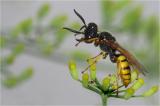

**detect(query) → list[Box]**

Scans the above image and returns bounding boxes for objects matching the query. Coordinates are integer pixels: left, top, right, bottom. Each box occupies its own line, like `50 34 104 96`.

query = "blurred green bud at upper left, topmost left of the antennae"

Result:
37 3 51 19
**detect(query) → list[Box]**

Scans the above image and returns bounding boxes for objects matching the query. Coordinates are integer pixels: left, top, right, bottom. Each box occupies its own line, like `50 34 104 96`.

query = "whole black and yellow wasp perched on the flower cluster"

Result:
64 9 147 87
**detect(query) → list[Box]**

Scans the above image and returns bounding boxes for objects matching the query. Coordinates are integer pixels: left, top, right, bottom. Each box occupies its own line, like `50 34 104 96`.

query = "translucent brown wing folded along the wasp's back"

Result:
105 40 147 75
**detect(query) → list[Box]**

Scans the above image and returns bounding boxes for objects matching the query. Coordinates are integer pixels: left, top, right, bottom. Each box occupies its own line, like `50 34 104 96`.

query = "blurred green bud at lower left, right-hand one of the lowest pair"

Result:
17 67 33 81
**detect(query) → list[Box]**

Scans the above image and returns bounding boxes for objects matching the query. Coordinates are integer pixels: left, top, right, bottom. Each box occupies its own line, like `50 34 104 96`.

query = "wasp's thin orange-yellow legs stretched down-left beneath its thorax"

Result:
82 52 107 73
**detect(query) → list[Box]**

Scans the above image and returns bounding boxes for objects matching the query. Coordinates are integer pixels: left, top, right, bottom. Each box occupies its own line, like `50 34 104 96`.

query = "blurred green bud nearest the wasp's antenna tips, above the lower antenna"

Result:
50 15 68 29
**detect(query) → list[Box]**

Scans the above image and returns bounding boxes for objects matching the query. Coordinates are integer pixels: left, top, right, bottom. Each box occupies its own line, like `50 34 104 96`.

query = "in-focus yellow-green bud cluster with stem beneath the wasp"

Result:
69 61 159 106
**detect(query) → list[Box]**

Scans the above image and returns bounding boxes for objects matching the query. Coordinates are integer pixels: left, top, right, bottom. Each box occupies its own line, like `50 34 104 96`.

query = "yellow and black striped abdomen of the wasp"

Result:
117 55 131 87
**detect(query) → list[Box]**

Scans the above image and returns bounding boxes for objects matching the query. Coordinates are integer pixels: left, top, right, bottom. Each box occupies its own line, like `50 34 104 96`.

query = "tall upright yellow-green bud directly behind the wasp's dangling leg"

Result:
88 59 96 80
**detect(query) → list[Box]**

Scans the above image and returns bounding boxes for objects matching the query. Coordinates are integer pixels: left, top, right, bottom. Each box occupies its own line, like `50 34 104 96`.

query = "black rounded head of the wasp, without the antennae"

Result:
85 23 98 39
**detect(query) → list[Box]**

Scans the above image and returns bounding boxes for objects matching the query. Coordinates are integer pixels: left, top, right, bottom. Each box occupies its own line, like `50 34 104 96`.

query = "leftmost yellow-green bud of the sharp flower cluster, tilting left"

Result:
69 61 78 80
